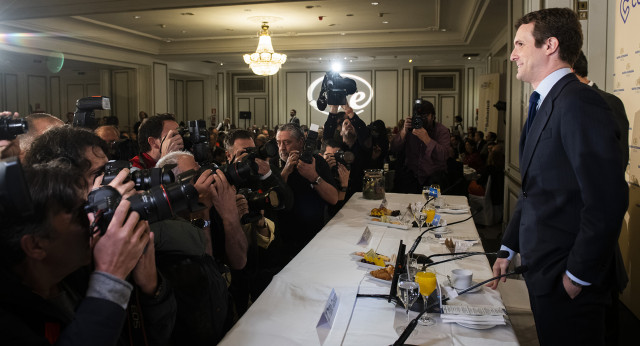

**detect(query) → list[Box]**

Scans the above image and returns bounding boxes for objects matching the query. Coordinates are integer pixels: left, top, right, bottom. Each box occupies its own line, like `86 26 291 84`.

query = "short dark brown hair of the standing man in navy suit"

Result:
515 8 583 66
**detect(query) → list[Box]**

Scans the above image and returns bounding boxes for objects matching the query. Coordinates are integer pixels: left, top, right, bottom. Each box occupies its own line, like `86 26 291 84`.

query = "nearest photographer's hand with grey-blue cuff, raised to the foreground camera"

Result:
89 200 150 280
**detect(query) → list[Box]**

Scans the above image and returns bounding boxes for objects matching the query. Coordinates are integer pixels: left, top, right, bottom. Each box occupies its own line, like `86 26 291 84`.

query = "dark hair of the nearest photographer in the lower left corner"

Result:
0 159 89 267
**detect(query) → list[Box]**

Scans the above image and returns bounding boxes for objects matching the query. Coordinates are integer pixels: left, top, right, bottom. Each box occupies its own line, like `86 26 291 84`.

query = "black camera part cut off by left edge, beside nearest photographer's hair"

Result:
0 157 33 216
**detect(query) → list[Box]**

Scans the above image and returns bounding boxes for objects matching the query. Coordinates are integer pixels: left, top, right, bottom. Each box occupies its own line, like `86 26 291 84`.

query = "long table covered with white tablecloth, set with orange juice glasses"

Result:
221 193 518 345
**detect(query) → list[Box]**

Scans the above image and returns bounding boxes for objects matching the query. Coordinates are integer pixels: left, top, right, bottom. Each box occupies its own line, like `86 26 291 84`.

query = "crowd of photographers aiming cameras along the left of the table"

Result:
0 74 504 345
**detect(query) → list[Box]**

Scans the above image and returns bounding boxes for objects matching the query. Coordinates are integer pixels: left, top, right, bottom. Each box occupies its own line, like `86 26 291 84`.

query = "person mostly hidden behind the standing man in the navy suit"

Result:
573 51 629 170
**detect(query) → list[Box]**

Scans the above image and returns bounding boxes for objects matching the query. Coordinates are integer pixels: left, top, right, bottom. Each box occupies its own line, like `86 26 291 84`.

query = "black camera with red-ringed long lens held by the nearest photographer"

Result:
84 176 201 235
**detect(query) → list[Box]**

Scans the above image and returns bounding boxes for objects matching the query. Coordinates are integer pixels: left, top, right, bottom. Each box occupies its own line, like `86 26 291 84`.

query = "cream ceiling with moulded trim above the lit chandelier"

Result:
0 0 507 68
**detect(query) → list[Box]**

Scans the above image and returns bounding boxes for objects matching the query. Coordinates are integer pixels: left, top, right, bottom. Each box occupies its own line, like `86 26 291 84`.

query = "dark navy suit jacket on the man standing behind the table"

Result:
503 74 628 295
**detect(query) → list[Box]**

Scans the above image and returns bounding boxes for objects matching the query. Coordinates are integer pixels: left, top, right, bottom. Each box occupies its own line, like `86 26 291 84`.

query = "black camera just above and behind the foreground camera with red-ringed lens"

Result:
102 160 176 190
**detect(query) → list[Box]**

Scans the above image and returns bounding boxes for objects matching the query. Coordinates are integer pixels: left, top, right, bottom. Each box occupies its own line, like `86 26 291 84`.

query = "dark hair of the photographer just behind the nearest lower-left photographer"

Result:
24 125 109 173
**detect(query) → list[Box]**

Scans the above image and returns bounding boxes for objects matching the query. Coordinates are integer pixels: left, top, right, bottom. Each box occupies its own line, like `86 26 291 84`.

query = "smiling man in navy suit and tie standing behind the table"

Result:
491 8 628 345
